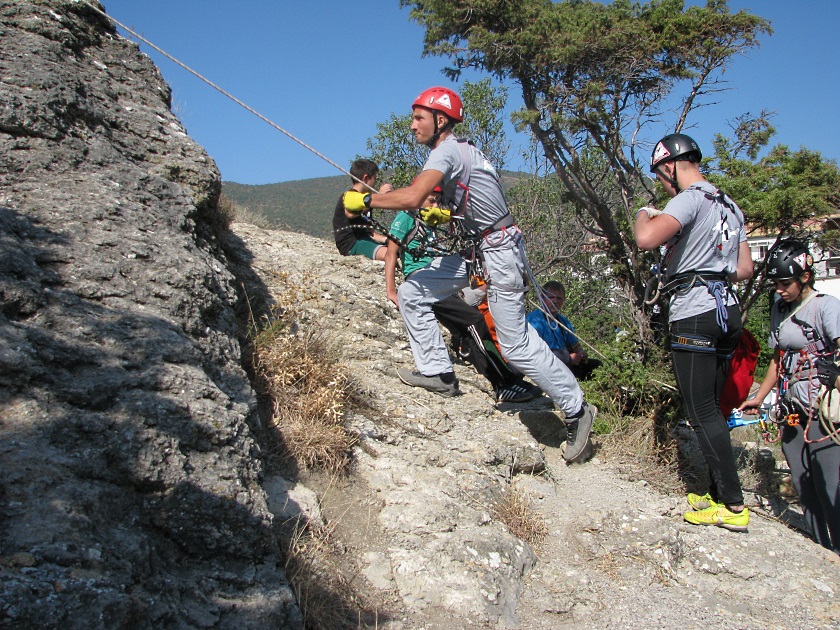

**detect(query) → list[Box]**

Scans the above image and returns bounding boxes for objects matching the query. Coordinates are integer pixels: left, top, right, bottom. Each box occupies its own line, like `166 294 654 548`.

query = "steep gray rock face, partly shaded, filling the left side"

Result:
0 0 300 628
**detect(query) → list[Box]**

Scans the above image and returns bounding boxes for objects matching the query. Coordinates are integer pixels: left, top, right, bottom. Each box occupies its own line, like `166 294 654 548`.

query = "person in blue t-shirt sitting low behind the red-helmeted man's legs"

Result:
525 280 601 381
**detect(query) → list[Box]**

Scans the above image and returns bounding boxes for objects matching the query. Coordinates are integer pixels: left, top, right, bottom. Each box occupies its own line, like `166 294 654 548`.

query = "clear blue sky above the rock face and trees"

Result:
102 0 840 184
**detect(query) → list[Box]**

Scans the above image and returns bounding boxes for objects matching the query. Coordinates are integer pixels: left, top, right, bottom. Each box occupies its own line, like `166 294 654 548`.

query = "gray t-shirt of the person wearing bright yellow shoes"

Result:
663 181 747 322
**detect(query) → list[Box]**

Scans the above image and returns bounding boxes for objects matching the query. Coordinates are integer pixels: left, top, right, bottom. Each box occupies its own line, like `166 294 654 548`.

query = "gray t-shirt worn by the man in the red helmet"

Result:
423 135 508 231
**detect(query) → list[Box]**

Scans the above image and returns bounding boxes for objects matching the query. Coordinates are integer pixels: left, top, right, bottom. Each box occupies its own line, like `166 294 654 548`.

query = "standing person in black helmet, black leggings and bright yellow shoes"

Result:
635 133 753 531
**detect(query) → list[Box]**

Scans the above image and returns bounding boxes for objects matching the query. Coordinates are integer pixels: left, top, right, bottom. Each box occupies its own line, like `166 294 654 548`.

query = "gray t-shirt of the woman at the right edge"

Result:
768 294 840 409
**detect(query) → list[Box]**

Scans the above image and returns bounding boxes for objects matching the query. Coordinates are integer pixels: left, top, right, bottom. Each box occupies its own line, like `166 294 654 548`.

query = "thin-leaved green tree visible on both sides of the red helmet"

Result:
367 78 510 187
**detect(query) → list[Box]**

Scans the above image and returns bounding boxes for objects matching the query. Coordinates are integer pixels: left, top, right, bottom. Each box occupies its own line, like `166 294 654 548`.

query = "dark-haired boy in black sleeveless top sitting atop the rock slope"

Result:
333 158 392 260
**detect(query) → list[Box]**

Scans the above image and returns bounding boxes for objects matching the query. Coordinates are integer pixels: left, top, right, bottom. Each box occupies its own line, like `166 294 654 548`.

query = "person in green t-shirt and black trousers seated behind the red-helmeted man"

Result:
385 187 535 402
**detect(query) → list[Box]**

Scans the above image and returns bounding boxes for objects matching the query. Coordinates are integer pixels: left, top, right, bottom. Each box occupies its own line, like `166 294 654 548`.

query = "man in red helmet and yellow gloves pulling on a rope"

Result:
344 87 597 463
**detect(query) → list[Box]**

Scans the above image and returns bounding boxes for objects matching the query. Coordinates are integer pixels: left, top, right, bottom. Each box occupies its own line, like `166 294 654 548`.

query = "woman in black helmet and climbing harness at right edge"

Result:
741 240 840 553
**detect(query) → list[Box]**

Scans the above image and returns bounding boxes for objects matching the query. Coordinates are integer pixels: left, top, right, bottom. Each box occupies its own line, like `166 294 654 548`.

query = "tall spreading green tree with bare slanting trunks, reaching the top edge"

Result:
401 0 770 301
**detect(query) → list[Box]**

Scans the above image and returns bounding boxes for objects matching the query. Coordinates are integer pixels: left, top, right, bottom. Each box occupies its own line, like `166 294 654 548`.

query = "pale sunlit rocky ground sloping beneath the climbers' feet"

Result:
234 224 840 629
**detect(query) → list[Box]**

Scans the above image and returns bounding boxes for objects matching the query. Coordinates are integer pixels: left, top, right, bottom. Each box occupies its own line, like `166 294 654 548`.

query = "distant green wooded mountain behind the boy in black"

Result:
222 171 523 240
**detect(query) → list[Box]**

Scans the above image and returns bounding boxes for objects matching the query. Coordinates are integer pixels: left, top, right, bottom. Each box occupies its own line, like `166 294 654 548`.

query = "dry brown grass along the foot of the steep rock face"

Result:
250 274 376 630
